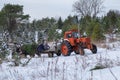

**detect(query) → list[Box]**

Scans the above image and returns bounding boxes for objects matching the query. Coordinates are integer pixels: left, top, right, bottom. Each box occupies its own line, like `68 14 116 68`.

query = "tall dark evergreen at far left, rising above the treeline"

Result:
0 4 29 39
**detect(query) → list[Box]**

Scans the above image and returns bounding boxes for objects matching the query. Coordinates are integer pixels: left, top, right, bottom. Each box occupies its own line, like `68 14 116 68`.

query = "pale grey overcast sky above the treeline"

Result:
0 0 120 20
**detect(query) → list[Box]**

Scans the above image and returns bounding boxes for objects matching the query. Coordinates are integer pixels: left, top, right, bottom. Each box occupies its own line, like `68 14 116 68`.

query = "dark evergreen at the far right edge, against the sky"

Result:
102 10 120 34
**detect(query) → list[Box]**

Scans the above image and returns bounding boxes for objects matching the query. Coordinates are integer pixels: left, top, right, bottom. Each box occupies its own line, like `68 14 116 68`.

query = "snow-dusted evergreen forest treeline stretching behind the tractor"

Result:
0 2 120 42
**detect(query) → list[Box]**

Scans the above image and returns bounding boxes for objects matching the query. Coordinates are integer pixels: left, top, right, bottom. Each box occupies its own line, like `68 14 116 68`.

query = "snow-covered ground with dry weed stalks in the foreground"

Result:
0 42 120 80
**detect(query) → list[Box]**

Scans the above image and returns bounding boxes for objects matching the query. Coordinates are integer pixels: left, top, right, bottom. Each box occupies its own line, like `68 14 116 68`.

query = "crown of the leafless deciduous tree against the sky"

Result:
73 0 104 17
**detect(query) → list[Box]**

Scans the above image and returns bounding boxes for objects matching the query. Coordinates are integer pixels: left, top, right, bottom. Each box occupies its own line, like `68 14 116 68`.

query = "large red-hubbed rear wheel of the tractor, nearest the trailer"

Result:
61 41 72 56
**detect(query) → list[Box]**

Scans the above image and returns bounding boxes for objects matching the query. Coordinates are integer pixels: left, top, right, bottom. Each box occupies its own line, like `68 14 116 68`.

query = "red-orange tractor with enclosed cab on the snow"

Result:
59 30 97 56
